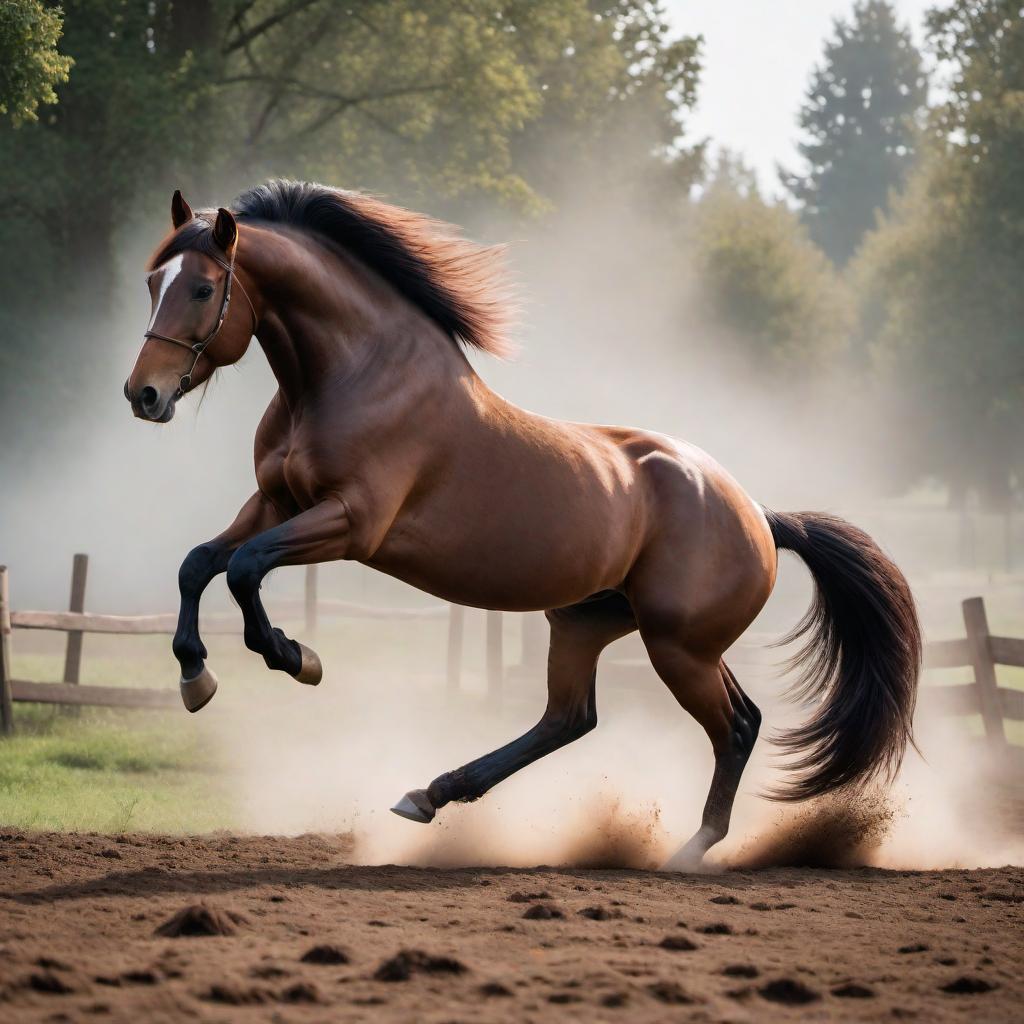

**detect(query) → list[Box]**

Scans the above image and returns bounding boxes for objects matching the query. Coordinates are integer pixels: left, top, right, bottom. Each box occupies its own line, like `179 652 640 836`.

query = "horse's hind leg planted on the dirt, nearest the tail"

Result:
641 625 761 871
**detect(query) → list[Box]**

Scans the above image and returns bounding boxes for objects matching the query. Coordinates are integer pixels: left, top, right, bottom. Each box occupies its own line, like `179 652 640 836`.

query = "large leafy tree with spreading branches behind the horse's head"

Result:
0 0 696 308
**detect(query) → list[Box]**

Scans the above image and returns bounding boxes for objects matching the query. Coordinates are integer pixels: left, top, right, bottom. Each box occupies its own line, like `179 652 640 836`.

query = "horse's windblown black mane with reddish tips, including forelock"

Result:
151 179 511 356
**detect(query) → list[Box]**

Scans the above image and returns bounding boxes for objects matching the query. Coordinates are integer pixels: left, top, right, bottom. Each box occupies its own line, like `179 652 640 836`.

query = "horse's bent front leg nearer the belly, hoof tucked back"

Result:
227 497 349 686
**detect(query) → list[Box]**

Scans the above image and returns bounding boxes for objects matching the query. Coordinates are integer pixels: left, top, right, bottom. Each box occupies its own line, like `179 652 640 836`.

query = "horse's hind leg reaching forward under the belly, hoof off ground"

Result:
391 593 636 823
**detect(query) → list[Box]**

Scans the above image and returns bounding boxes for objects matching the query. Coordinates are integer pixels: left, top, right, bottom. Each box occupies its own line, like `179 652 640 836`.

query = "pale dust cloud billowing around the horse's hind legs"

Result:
195 614 1024 870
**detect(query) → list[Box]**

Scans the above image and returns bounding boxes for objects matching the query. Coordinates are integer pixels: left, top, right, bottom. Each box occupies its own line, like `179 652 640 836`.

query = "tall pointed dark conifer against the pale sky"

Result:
781 0 927 266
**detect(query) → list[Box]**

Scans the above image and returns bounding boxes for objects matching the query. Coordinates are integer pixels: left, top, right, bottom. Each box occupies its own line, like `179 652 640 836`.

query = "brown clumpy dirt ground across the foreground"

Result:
0 831 1024 1022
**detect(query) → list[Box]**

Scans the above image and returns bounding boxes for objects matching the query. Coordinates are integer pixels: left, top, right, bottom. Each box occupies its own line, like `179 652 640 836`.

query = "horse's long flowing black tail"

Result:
765 509 921 800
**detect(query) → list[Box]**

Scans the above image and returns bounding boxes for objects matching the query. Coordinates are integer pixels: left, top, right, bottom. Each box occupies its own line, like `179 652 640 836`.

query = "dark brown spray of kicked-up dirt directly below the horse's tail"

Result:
727 791 895 868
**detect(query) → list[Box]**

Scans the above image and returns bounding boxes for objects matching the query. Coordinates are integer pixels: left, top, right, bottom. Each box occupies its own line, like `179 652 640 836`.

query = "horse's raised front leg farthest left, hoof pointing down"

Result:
171 492 282 712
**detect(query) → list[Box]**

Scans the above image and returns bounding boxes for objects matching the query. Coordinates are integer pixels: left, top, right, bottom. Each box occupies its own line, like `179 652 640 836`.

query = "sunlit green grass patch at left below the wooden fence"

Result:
0 705 231 833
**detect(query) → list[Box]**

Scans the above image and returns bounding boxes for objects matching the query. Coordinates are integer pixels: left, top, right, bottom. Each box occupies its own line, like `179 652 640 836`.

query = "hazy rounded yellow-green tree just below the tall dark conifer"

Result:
691 154 852 373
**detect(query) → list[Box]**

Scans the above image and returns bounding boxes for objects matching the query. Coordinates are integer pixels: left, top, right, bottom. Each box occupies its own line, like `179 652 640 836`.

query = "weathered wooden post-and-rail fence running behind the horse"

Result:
0 554 1024 749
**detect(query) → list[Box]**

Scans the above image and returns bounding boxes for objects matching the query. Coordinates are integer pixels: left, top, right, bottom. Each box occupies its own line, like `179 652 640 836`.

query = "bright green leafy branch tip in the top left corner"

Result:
0 0 72 126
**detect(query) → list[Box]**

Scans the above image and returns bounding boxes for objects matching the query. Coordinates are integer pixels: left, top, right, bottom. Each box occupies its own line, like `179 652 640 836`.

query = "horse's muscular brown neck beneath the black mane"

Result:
239 227 475 409
